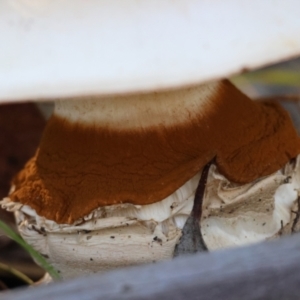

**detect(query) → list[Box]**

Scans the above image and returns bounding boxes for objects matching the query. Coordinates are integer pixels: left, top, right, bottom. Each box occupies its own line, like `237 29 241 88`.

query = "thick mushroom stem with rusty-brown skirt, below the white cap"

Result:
1 81 300 278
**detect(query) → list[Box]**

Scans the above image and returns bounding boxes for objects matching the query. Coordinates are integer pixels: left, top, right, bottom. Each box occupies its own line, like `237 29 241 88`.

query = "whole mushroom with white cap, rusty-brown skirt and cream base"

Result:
0 0 300 278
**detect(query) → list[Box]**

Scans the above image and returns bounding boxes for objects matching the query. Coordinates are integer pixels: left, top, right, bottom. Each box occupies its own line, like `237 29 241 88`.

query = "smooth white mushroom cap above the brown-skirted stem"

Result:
0 0 300 101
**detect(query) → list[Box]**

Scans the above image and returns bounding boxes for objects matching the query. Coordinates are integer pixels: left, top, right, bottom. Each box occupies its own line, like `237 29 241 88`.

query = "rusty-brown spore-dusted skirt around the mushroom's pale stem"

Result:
10 81 300 224
